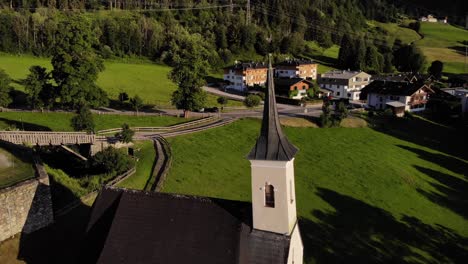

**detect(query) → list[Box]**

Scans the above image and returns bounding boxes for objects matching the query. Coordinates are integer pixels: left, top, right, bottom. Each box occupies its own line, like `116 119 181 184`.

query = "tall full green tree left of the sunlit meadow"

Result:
52 14 107 108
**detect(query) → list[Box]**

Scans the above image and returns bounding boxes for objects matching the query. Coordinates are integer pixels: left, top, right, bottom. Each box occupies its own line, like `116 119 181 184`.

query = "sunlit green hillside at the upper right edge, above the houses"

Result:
416 22 468 73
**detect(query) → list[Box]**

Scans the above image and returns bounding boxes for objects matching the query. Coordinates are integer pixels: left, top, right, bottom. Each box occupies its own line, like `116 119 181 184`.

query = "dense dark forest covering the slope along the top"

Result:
0 0 463 71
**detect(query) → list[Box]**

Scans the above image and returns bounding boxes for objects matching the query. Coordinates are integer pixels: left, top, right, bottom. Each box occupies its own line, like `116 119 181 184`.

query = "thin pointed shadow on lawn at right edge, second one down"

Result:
397 145 468 175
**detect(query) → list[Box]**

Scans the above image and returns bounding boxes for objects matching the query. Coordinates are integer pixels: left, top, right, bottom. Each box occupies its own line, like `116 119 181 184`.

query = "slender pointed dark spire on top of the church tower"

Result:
247 57 297 161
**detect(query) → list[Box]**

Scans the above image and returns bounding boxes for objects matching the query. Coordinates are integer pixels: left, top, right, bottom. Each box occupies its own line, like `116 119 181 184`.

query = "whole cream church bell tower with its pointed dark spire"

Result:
247 56 297 235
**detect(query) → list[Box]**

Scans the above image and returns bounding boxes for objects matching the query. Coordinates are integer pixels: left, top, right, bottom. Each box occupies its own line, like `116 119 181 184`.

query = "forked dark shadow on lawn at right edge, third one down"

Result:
414 166 468 219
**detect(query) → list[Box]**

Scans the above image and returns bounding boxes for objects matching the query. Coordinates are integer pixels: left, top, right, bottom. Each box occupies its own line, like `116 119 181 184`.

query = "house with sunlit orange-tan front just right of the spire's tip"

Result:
275 59 317 80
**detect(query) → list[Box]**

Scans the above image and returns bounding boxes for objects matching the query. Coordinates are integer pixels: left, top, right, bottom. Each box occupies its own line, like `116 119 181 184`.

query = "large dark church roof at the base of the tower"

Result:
80 187 290 264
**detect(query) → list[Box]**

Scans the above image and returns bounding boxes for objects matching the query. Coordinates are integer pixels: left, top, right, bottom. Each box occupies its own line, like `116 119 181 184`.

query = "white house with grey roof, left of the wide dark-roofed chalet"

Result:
317 70 371 100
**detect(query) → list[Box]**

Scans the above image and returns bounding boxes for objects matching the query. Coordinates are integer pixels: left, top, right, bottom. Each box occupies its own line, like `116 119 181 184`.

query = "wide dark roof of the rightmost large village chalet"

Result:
361 80 432 96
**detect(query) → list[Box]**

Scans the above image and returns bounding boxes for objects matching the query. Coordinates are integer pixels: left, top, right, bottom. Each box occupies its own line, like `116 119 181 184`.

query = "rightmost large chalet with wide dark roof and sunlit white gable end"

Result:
366 81 434 115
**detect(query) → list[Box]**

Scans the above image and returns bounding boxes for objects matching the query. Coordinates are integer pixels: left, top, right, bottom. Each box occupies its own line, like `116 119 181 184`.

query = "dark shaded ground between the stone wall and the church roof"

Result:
17 180 90 264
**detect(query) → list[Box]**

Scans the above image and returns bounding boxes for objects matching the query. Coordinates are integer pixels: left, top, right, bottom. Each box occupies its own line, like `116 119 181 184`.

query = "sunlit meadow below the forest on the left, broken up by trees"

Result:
0 53 242 107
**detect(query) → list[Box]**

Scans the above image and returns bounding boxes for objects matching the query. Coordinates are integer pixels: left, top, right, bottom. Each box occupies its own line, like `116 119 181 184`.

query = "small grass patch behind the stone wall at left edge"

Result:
0 148 35 188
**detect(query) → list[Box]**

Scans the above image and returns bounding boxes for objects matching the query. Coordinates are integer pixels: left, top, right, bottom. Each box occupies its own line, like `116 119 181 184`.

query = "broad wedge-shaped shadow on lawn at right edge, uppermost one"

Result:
368 117 468 160
